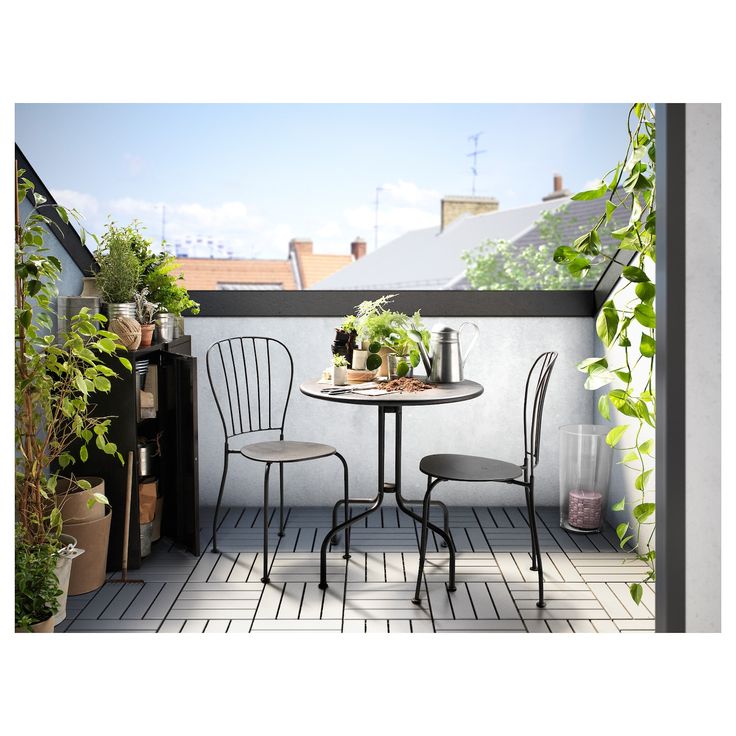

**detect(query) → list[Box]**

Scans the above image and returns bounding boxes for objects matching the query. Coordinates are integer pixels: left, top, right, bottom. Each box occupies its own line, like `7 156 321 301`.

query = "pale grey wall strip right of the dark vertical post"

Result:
685 105 721 631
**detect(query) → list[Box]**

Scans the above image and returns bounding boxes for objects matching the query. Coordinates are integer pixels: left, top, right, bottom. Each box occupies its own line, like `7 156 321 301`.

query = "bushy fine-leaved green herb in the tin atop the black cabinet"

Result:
94 222 141 304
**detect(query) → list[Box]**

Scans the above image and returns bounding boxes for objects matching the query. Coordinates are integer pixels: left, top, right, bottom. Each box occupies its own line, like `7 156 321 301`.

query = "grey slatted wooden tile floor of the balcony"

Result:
56 506 654 634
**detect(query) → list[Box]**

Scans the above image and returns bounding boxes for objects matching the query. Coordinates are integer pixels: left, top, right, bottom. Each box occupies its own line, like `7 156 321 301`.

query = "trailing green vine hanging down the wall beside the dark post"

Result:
554 102 657 604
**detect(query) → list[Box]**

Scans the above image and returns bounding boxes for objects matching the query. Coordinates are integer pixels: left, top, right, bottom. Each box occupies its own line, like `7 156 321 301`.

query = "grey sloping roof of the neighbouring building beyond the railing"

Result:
312 198 620 290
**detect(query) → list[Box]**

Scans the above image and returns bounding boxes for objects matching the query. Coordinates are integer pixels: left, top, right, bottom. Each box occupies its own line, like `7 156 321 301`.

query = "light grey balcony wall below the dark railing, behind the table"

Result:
186 316 595 506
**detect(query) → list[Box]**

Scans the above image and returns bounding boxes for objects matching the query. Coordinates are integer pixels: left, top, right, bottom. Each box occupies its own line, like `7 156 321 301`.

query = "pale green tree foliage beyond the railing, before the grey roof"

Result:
462 204 610 291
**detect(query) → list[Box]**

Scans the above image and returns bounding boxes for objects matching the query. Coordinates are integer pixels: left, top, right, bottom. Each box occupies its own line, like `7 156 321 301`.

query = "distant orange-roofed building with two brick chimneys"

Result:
177 238 366 291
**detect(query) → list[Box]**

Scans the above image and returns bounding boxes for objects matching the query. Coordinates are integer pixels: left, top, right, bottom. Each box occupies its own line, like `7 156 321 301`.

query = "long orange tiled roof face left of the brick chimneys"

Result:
172 258 296 291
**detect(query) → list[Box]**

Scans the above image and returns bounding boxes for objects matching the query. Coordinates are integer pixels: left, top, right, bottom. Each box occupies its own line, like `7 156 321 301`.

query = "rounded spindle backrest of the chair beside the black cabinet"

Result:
206 337 294 441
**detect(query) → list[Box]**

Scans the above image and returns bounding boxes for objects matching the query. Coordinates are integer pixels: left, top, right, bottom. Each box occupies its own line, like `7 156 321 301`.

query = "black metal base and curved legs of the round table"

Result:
319 406 456 592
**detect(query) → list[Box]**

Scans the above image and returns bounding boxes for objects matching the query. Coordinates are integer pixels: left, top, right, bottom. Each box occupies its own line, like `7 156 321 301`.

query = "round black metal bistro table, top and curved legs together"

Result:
299 381 483 591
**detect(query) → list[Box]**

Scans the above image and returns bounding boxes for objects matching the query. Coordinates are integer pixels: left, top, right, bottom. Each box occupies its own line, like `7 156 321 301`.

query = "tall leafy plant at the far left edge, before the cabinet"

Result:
15 171 131 630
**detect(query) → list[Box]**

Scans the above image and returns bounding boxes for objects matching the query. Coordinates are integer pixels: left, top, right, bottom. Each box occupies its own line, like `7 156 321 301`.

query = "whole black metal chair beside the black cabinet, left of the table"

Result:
206 337 350 583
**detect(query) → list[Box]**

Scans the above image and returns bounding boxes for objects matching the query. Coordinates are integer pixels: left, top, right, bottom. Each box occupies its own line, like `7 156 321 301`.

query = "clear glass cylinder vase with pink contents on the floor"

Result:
560 424 613 534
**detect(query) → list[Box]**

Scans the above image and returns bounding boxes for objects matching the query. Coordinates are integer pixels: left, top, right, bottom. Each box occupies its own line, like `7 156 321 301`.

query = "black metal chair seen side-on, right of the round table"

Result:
412 353 557 608
